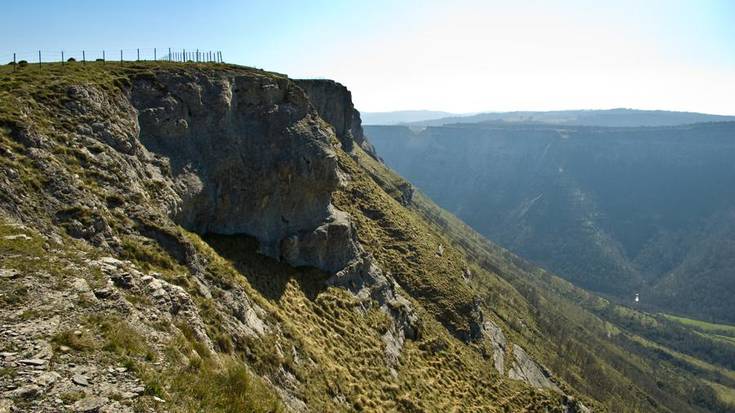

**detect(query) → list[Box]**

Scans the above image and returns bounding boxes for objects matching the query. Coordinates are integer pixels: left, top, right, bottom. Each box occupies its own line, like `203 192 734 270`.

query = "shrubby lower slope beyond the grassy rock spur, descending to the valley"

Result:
350 146 735 411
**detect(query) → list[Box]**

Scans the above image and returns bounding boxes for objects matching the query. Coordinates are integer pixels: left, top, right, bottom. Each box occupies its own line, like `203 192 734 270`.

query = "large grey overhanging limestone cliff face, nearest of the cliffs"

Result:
131 72 359 273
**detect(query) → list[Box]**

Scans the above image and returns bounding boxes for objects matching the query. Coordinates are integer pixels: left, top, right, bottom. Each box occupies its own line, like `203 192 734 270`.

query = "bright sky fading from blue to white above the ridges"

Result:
0 0 735 115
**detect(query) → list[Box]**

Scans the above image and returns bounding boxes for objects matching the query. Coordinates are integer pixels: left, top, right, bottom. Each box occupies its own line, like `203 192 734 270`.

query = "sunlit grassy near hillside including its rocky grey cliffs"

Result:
0 62 735 412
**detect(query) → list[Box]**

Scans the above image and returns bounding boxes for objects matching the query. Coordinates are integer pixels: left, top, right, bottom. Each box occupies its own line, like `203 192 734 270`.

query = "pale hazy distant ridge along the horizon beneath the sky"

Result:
363 108 735 127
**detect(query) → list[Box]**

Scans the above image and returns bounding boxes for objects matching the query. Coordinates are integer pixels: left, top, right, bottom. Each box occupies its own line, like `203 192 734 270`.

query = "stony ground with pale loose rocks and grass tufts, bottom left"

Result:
0 224 196 413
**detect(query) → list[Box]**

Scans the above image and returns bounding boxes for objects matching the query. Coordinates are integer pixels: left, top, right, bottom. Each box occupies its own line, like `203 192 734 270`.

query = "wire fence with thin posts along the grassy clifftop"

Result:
0 47 224 66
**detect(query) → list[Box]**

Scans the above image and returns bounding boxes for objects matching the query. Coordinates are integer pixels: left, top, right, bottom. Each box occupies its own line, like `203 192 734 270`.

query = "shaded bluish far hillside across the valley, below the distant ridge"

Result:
367 122 735 323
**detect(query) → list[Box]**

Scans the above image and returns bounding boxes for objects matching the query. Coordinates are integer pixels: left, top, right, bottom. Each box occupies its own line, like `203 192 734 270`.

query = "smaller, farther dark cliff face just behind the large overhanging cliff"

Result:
296 79 377 158
